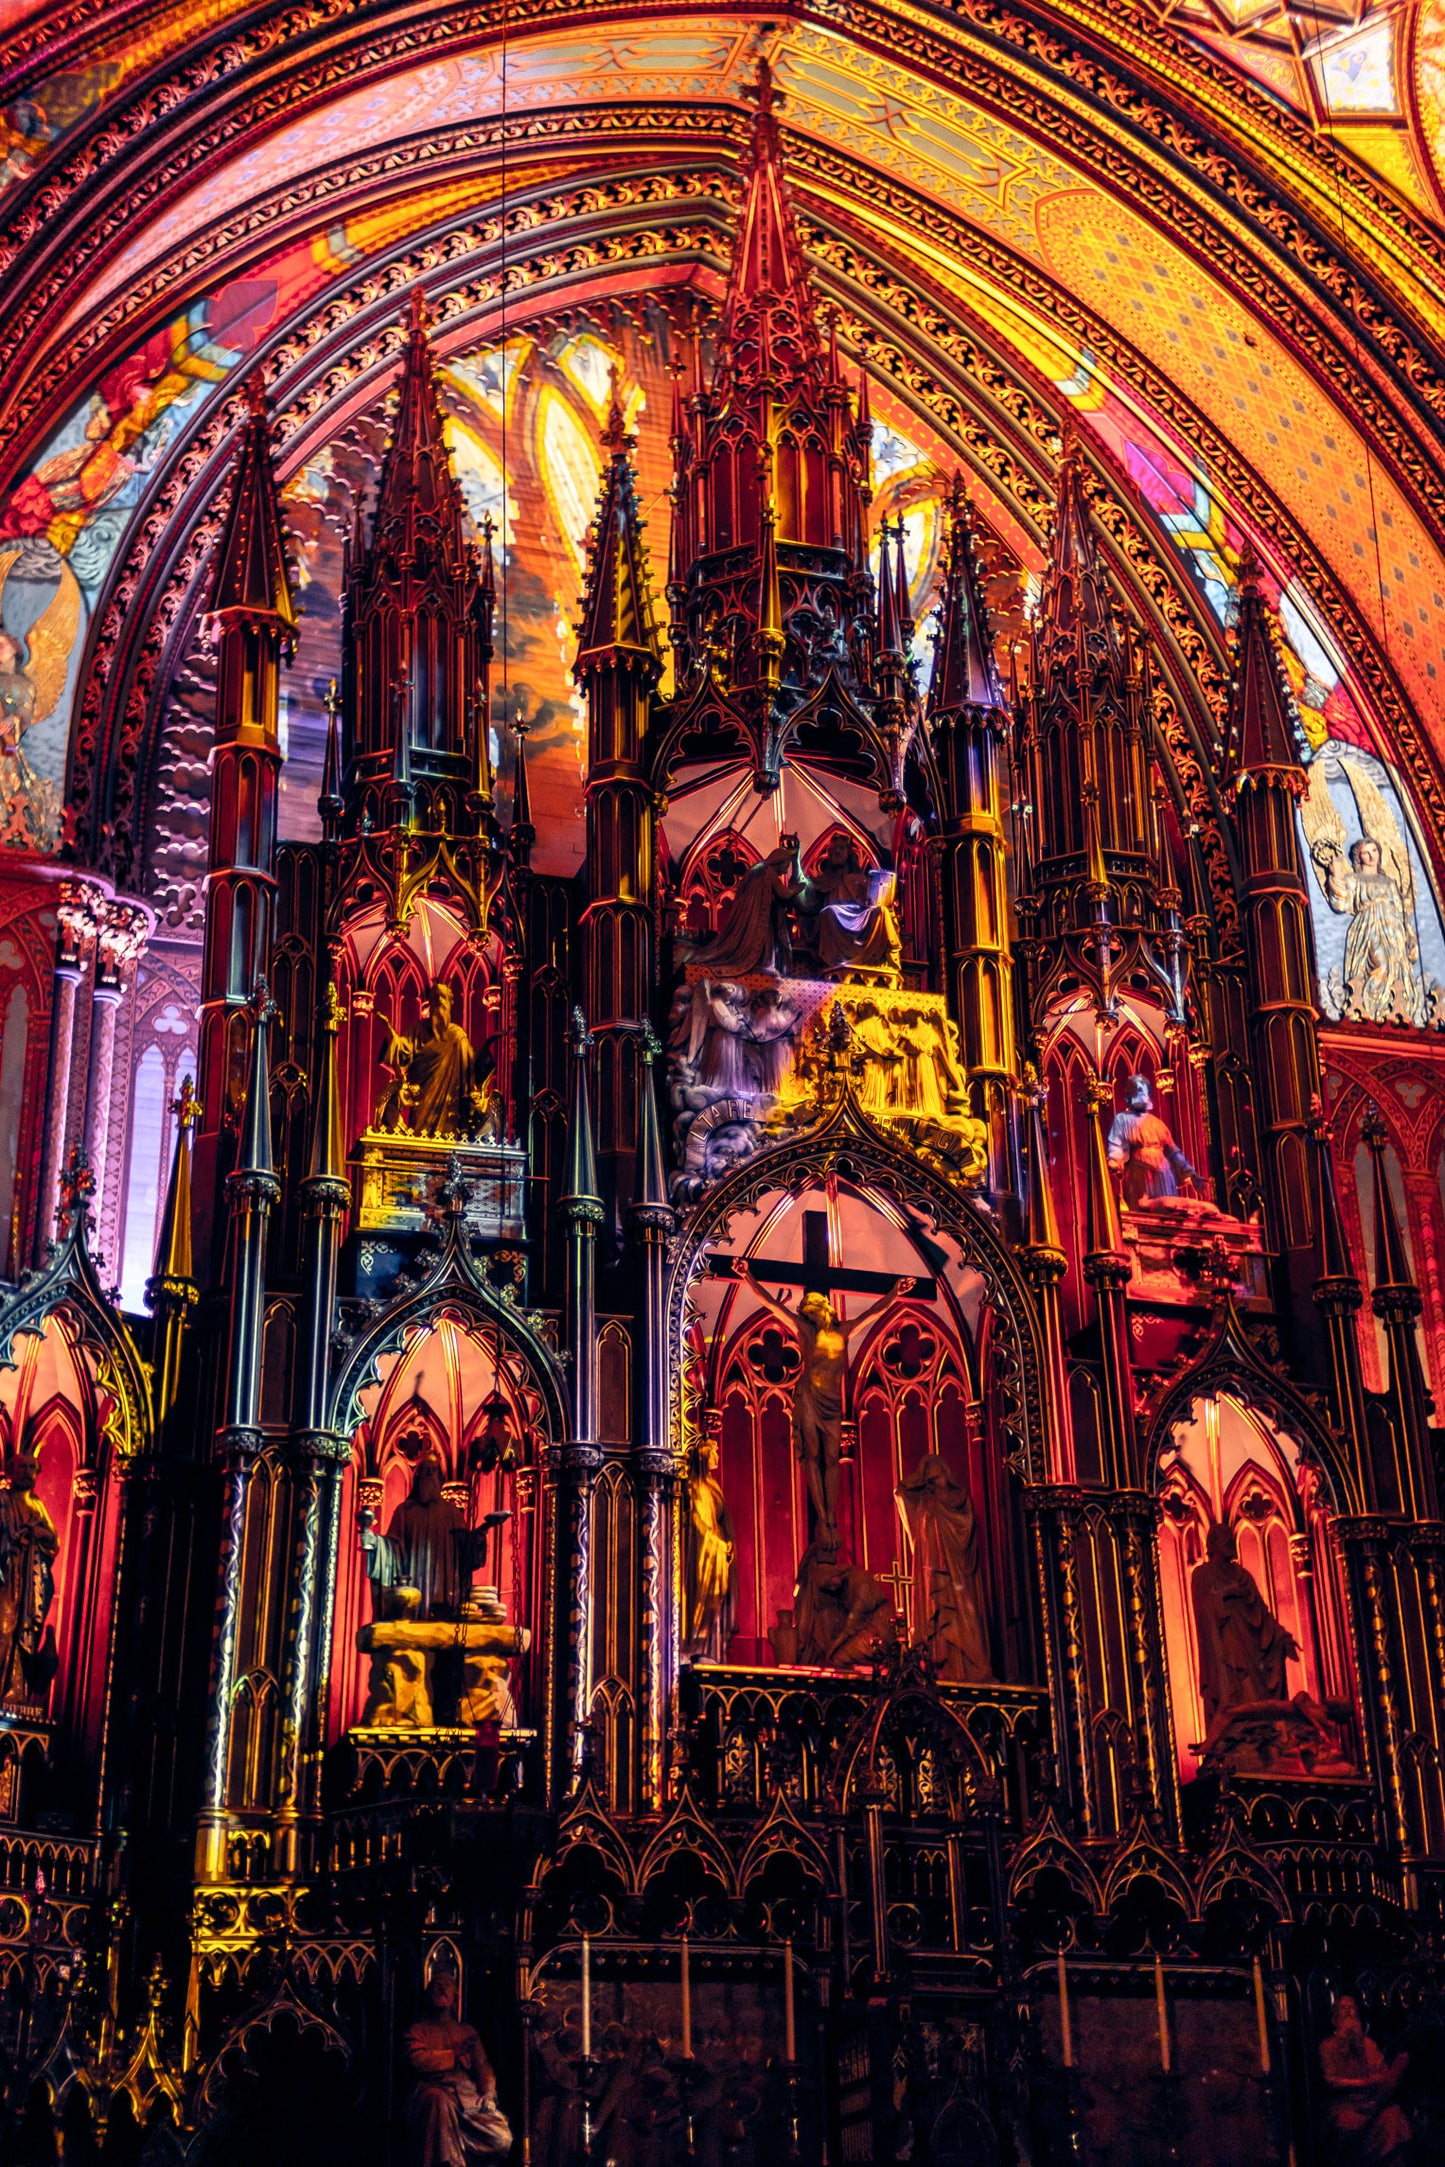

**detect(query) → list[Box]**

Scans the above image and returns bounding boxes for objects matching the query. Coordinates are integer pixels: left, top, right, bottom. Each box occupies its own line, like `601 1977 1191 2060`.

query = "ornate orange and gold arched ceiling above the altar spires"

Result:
0 0 1445 905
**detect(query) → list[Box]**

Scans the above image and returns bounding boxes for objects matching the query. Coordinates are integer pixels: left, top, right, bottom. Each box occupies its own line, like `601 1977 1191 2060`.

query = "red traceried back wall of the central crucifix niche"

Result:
687 1177 1027 1677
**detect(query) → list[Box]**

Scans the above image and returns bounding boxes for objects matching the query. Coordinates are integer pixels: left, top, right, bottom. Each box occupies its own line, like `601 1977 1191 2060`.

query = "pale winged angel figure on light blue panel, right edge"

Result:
1300 745 1426 1023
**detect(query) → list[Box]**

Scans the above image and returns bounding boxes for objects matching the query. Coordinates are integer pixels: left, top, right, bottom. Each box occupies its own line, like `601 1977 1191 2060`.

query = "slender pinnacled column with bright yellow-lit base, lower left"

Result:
195 979 282 1881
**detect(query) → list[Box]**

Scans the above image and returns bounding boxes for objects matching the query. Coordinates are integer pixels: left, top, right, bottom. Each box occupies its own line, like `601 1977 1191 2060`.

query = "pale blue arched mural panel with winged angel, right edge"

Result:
1300 739 1445 1025
